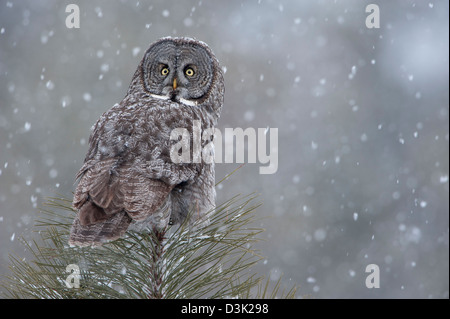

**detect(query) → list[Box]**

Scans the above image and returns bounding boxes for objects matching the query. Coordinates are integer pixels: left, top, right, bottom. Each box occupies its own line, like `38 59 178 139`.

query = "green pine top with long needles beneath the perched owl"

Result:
0 195 295 299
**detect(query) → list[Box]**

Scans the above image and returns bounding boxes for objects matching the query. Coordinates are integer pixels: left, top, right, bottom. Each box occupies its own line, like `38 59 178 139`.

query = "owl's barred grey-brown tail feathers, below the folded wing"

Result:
69 211 131 247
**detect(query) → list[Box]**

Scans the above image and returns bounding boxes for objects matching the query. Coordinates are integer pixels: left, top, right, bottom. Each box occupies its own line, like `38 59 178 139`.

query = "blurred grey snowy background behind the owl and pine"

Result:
0 0 449 298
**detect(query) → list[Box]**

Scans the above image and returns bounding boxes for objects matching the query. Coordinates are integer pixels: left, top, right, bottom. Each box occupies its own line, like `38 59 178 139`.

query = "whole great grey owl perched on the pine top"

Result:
69 37 224 246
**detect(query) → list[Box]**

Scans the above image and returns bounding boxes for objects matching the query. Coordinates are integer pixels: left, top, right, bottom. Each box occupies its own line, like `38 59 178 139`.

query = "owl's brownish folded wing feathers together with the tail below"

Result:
69 159 173 246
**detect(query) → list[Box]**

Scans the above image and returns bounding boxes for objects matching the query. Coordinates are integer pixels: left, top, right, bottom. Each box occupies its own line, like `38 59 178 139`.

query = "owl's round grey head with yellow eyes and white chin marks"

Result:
138 37 223 107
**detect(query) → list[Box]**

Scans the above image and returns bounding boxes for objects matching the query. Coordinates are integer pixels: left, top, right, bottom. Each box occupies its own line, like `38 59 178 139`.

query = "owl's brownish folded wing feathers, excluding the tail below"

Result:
73 159 173 225
